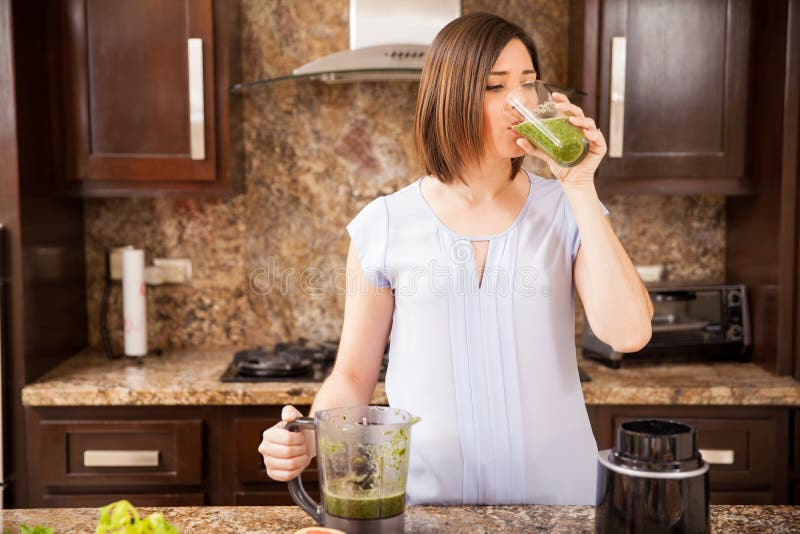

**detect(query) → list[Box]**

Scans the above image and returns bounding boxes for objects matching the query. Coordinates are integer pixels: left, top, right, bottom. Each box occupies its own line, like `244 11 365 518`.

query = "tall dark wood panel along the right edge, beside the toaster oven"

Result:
725 0 797 374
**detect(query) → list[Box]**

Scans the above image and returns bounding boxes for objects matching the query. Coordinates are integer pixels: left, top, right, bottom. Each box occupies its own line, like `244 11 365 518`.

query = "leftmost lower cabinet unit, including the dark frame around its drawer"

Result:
26 406 221 507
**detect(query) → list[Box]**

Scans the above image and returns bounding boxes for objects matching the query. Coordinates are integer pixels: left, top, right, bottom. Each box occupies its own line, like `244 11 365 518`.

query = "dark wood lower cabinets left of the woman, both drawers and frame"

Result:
26 406 319 507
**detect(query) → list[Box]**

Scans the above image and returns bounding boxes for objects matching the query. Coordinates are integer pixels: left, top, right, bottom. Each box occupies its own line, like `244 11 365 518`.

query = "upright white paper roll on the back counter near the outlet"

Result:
122 249 147 356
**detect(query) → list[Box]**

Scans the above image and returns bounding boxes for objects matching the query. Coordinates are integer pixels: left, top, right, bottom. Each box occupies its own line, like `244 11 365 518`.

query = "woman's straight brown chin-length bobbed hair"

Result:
414 13 541 183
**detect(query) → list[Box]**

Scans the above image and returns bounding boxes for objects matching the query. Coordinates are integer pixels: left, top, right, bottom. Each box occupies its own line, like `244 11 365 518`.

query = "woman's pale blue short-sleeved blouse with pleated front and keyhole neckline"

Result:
347 174 608 505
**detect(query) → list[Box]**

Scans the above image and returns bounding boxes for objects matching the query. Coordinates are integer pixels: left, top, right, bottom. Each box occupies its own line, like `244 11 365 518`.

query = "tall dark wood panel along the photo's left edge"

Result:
0 0 86 506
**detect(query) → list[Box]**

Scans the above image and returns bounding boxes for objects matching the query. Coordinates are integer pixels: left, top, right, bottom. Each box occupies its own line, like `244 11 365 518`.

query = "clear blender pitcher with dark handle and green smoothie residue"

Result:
286 406 419 534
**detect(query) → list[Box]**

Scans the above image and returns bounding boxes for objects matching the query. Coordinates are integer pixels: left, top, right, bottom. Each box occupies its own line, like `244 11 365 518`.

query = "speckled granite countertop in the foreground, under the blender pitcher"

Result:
0 506 800 534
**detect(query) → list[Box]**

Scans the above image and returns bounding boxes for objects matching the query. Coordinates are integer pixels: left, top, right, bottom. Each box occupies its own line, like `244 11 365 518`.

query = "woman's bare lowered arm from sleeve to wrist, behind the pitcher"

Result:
306 243 394 457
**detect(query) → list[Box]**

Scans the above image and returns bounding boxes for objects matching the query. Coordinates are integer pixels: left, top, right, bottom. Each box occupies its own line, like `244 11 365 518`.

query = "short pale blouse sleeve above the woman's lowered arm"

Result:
347 197 390 287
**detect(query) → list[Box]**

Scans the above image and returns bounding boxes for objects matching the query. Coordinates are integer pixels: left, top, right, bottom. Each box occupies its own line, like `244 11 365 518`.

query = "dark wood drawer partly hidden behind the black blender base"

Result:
613 414 778 490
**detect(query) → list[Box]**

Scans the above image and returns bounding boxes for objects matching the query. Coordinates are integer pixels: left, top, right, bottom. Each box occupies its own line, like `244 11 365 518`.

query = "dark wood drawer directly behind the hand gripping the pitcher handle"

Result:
233 417 318 484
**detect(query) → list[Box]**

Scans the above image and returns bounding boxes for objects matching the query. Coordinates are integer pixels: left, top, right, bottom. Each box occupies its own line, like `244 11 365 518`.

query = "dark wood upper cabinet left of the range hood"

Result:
50 0 238 196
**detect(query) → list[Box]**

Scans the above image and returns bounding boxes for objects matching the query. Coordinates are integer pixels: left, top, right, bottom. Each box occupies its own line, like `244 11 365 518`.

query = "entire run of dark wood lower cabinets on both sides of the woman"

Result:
27 406 800 507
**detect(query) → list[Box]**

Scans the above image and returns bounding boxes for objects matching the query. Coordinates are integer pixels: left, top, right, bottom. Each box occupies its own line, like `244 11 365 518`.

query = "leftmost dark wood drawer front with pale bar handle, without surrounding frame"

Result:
39 419 203 488
